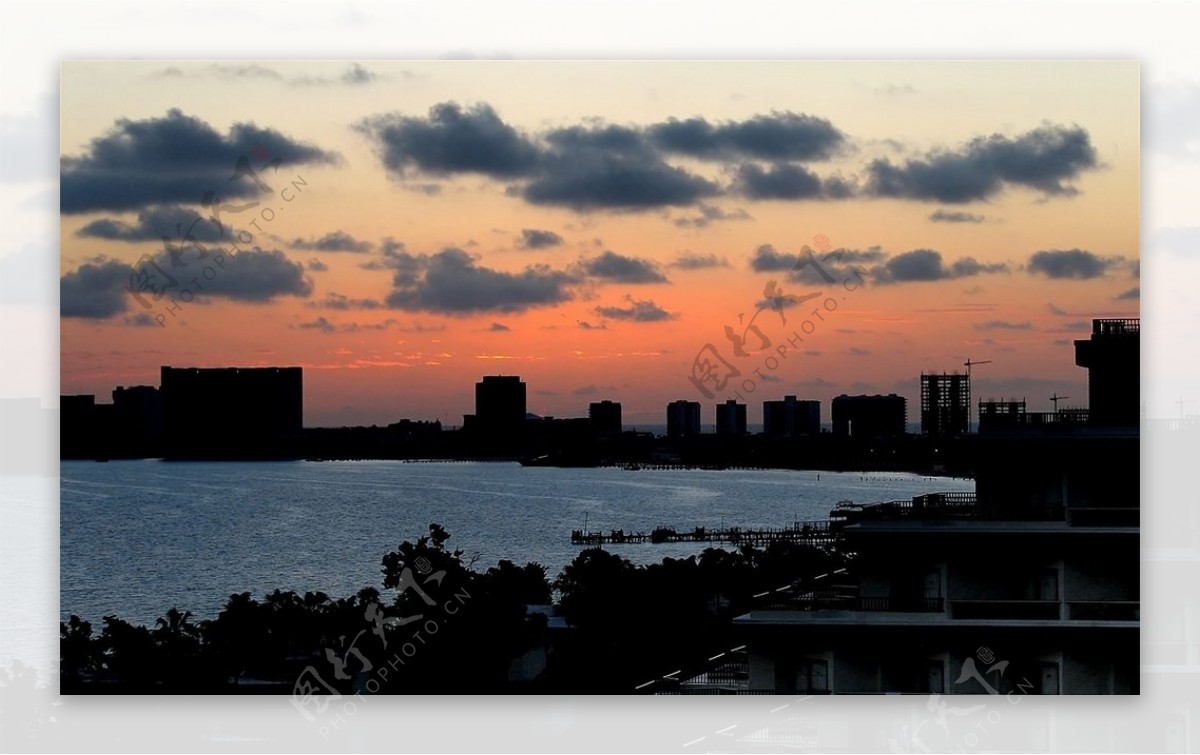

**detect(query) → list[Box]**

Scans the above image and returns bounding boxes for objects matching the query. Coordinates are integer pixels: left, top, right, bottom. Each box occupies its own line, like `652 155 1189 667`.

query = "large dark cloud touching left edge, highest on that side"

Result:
60 109 341 214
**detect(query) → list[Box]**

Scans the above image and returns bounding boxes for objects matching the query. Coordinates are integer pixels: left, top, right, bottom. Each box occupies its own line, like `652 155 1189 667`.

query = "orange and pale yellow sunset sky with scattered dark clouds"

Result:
60 61 1140 426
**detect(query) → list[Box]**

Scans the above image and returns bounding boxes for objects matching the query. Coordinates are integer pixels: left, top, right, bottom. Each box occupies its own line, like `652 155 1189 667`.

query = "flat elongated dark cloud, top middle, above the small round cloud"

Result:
647 112 845 160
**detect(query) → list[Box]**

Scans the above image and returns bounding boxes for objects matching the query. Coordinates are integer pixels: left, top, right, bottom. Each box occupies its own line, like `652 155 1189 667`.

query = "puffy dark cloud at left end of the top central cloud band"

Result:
355 102 539 178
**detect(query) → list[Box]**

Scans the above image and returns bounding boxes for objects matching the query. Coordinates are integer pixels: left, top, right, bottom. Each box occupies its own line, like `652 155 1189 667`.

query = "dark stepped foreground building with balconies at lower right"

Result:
734 319 1140 694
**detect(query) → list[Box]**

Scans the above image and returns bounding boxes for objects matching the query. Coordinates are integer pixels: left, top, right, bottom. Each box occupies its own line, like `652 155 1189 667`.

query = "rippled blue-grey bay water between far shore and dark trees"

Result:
59 461 974 624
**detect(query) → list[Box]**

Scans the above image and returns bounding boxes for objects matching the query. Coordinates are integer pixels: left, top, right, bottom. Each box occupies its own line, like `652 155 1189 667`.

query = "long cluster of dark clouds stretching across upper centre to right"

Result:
355 102 1099 210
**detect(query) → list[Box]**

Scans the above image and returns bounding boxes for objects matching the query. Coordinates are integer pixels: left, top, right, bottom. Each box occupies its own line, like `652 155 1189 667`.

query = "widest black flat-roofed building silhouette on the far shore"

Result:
161 367 304 459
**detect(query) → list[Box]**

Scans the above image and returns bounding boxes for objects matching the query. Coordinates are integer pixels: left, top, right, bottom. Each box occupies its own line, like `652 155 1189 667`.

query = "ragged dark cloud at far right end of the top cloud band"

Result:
866 125 1099 203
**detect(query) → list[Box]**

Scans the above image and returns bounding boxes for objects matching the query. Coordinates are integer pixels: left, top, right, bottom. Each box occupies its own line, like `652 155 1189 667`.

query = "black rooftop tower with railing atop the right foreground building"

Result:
1075 318 1141 427
